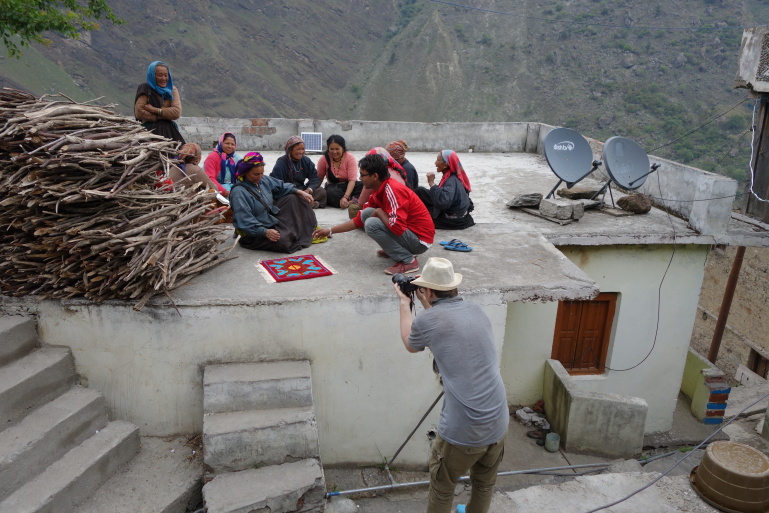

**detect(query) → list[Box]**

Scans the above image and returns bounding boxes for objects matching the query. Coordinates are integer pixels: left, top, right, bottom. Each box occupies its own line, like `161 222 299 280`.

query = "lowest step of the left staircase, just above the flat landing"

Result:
0 421 139 513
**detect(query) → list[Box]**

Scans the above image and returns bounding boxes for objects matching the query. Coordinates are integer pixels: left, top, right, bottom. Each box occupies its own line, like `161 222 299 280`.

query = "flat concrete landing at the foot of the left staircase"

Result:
75 437 203 513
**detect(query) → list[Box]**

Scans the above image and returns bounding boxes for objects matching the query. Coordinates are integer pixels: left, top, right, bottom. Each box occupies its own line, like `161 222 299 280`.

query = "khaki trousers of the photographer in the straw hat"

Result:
427 435 505 513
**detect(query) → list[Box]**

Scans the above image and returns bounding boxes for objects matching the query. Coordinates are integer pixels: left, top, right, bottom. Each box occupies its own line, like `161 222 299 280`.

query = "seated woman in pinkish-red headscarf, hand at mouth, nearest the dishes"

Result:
416 150 475 230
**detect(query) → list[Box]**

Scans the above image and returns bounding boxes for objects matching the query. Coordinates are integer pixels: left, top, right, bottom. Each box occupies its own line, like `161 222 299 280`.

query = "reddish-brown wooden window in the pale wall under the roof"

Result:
550 292 617 374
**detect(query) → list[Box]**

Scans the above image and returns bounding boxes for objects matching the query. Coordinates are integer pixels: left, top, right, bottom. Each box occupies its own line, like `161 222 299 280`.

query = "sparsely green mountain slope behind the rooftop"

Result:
0 0 769 183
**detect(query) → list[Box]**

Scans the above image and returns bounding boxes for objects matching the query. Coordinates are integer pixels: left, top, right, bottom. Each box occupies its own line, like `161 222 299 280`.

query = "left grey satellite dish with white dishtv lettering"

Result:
545 128 601 198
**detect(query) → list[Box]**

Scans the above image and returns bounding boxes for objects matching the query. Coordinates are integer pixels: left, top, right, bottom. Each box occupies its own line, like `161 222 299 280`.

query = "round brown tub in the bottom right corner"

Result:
689 442 769 513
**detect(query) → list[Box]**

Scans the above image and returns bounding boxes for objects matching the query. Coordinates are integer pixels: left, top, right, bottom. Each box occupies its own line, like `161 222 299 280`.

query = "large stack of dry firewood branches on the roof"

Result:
0 89 227 309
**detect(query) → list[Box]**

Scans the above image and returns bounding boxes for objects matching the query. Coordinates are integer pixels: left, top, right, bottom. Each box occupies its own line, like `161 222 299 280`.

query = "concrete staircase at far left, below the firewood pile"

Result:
0 317 201 513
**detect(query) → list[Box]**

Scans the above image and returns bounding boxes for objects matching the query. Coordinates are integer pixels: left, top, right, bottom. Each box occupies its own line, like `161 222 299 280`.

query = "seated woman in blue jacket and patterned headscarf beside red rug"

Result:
230 152 317 253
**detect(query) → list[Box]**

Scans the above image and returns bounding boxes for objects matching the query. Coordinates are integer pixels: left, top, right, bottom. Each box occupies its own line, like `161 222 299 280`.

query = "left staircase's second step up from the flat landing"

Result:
0 387 108 500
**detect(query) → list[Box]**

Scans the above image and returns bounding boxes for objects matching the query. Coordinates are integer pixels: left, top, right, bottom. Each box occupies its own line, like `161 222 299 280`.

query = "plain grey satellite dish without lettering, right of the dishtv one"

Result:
593 136 660 204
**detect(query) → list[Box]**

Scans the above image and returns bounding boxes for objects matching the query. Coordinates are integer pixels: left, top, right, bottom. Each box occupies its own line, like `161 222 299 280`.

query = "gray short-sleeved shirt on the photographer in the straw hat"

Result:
409 297 510 447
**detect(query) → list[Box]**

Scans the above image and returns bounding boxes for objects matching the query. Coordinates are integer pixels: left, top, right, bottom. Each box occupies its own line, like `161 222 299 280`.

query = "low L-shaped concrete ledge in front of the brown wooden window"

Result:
544 360 648 458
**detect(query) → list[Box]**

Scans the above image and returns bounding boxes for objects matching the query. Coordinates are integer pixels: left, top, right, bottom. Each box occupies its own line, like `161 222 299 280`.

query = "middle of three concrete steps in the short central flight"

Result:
203 408 319 474
